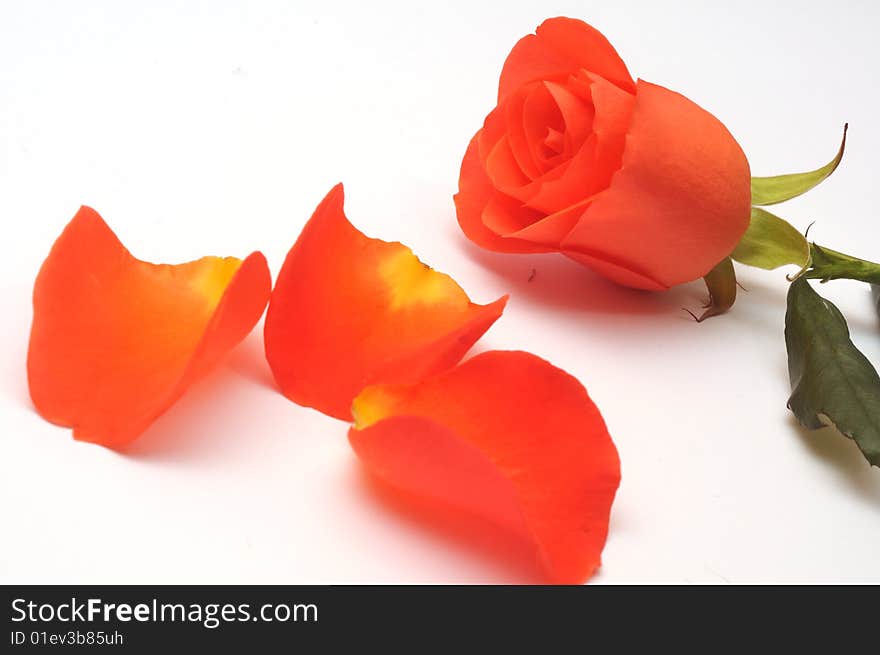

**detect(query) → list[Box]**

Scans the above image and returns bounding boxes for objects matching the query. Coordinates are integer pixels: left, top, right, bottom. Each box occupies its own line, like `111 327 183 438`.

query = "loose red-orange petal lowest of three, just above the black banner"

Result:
349 351 620 583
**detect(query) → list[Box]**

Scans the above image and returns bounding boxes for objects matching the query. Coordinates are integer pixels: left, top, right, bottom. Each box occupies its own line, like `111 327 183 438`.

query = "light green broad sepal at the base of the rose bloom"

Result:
731 207 810 271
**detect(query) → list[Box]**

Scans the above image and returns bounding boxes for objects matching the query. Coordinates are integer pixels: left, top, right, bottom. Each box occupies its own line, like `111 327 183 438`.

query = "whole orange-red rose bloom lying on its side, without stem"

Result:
455 18 751 289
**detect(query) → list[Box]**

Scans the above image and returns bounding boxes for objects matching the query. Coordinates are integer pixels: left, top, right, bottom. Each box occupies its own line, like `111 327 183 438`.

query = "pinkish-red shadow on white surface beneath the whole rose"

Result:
457 234 706 320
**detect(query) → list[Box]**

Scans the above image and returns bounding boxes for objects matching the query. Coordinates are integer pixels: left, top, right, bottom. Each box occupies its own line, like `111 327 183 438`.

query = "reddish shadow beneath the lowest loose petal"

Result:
356 466 547 584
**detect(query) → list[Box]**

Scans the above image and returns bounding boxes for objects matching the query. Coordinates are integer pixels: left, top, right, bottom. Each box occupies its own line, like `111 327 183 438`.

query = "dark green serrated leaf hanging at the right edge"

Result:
785 278 880 466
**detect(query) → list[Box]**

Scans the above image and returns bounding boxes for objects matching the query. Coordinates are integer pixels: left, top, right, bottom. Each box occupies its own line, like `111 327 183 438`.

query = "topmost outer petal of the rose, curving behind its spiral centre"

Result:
498 18 635 104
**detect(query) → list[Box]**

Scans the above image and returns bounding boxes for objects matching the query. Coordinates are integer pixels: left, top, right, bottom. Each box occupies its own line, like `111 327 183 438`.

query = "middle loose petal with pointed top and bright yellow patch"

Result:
265 185 507 420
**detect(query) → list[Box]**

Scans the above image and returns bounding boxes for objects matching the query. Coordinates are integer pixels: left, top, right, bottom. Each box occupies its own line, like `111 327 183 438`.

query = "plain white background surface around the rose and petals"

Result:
0 0 880 583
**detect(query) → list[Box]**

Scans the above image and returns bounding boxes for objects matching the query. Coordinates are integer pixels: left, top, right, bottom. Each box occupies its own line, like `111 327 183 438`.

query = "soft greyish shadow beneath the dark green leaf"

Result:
789 416 880 509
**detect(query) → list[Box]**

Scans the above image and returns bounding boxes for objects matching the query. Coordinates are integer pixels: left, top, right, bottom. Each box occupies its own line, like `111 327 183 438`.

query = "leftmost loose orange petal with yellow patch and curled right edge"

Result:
27 207 271 448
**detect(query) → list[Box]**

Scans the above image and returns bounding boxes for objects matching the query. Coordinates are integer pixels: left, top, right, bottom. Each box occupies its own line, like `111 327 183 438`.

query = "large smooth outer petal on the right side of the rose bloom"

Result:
562 80 751 288
